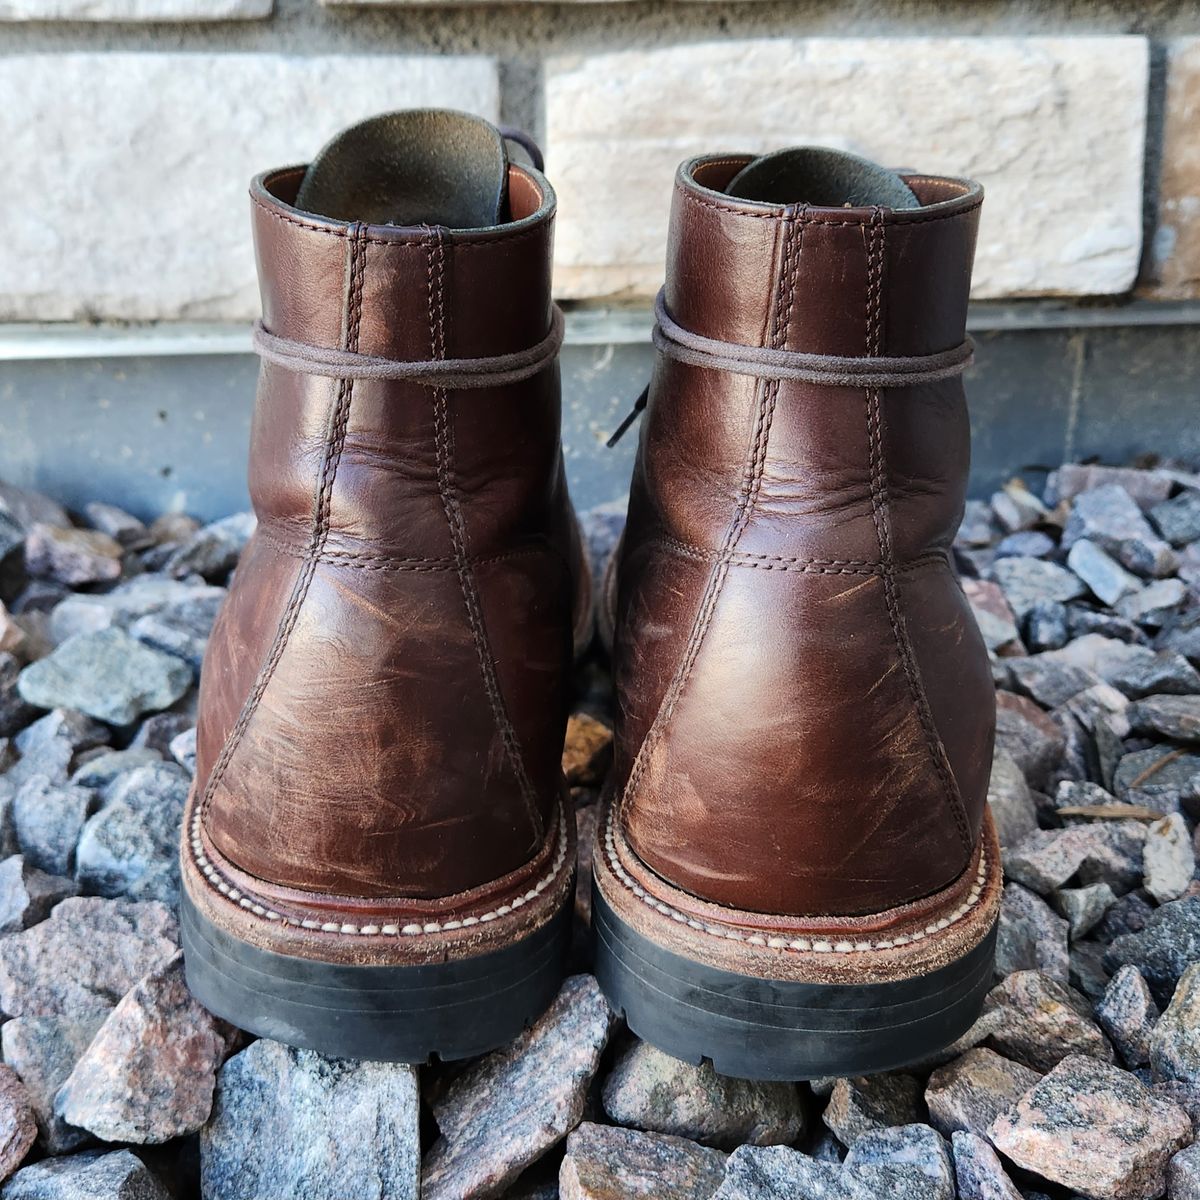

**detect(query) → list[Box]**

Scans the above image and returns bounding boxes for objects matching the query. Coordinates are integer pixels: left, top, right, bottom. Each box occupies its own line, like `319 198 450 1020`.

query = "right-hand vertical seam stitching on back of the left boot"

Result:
426 228 545 845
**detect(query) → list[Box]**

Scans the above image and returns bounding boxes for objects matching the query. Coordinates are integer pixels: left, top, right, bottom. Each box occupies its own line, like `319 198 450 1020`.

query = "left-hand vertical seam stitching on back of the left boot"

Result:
199 222 366 818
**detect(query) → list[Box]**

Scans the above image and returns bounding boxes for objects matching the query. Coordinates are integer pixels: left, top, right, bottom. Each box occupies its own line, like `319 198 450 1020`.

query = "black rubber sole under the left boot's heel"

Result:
181 892 571 1063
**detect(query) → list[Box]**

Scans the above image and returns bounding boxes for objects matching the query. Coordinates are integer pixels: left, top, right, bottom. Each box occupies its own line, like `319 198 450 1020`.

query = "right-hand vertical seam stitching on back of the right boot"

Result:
864 206 973 852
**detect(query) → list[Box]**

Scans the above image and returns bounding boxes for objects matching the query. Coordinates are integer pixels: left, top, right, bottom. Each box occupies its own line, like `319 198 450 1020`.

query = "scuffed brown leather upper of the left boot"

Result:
197 166 587 898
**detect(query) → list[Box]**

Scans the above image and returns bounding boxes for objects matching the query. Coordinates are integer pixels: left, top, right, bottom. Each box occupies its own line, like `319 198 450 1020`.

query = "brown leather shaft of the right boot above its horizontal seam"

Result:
638 156 982 560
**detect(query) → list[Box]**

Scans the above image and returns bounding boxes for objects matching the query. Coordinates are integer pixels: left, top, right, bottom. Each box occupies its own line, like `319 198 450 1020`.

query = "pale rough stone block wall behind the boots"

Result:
0 0 1200 322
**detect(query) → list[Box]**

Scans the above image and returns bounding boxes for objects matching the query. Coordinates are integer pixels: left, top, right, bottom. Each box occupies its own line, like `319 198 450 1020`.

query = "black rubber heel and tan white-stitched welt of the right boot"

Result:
592 810 1003 1080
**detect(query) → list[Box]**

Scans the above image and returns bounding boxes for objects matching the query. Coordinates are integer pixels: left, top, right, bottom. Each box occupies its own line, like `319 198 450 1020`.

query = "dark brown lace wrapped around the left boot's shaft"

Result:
254 305 563 389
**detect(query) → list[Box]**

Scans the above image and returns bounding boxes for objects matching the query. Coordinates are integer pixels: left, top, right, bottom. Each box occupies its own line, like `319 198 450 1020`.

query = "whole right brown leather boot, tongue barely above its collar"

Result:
595 150 1001 1079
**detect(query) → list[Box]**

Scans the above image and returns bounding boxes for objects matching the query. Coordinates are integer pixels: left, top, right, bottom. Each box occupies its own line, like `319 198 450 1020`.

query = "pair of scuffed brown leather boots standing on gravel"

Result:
182 112 1001 1079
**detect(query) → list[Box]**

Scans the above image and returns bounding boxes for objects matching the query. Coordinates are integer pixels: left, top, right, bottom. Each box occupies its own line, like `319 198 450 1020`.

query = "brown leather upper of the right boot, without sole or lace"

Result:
614 156 995 916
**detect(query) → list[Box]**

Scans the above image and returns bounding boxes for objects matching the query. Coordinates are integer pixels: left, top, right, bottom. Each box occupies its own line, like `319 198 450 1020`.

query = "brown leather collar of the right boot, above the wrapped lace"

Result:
665 155 983 355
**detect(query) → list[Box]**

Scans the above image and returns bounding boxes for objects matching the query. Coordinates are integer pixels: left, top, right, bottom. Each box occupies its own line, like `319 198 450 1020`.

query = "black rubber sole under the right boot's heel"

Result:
592 887 996 1080
